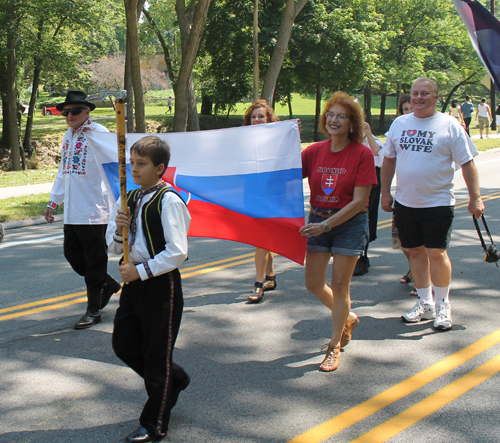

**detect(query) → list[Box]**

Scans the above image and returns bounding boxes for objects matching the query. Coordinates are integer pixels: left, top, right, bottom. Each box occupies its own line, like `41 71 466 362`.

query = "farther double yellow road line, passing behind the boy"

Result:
0 252 254 321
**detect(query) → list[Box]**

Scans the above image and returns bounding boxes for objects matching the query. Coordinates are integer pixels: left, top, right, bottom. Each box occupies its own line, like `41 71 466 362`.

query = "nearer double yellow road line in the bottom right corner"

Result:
287 329 500 443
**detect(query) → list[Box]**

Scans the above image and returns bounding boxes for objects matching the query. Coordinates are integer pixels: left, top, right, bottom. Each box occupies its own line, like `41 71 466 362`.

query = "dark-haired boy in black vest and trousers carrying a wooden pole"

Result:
107 136 191 442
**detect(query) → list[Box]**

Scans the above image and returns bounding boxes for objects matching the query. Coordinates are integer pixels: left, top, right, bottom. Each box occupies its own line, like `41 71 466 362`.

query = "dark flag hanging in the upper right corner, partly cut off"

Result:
453 0 500 91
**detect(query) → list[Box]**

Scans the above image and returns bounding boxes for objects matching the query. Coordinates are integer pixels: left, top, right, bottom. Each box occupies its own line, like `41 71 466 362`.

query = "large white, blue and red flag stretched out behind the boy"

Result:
85 120 306 264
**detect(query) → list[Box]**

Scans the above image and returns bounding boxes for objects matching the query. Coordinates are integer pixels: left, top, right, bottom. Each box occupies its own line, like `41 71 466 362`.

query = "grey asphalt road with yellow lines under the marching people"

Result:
0 152 500 443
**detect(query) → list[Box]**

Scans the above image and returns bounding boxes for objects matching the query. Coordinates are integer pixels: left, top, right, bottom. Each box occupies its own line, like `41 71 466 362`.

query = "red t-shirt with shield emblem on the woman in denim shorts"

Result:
302 139 377 209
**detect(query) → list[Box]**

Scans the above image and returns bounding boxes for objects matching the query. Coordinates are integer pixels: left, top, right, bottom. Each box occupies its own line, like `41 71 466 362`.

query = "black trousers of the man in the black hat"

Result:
64 225 112 312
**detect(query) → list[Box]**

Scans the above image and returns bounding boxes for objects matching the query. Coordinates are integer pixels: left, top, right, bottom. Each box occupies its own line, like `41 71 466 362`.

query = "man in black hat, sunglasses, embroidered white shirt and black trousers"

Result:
44 91 121 329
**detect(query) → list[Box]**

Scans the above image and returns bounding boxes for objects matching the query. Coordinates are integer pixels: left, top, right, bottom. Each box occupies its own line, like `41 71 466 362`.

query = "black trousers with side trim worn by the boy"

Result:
113 269 187 434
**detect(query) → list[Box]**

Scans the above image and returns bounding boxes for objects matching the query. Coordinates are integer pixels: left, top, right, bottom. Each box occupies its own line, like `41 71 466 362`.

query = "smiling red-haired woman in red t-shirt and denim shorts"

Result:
300 92 377 372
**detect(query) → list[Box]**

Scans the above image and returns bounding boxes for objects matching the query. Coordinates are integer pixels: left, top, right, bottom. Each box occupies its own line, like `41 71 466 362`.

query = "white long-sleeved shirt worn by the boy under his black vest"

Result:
106 192 191 280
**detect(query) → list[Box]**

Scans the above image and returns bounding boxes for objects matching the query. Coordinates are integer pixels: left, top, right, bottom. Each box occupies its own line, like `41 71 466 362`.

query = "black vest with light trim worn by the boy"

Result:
127 186 184 258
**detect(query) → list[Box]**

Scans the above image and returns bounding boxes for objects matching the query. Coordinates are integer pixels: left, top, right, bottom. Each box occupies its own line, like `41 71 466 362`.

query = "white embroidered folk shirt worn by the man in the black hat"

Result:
49 119 111 225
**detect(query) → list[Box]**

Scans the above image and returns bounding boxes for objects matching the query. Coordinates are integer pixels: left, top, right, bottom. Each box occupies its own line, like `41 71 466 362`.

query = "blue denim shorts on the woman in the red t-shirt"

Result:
307 208 369 256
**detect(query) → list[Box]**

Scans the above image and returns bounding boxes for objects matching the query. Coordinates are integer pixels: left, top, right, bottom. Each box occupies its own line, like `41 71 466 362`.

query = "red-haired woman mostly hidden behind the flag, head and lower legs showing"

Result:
243 100 279 303
